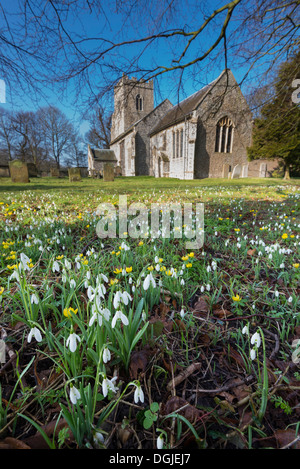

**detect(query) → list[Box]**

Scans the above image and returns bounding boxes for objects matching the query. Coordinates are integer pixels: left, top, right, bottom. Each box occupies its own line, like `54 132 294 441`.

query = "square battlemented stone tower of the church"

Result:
111 75 154 141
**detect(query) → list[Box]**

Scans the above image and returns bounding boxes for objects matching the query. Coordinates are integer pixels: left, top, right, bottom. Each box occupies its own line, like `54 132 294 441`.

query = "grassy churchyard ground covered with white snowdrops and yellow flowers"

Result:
0 177 300 452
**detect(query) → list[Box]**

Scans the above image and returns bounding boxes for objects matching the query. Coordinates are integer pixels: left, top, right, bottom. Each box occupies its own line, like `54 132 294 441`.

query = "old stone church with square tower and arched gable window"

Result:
106 69 280 179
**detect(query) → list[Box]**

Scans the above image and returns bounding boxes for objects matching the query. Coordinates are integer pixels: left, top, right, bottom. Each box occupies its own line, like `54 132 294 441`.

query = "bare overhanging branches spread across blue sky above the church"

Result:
0 0 300 107
